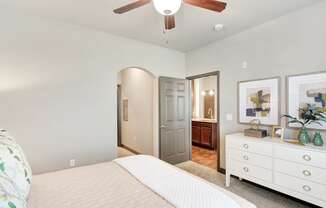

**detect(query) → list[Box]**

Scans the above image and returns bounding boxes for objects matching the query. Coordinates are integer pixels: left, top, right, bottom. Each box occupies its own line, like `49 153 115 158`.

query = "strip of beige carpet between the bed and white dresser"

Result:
177 161 313 208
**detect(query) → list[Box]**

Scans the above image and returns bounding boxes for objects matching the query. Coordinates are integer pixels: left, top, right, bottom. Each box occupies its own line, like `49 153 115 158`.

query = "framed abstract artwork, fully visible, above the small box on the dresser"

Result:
238 77 281 126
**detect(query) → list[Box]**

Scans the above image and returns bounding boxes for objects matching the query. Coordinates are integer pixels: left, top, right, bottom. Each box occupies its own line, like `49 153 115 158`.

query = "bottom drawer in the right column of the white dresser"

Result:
274 173 326 201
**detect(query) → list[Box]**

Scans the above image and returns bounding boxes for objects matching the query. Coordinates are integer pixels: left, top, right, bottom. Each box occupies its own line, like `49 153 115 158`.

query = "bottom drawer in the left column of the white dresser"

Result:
230 159 273 182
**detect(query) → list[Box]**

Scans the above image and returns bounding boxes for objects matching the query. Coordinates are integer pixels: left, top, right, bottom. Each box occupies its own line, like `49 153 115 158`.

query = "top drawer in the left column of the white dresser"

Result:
227 139 273 156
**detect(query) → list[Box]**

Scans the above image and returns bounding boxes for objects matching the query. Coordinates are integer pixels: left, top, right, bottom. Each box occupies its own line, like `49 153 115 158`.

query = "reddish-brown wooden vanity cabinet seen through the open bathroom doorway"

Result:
192 121 217 149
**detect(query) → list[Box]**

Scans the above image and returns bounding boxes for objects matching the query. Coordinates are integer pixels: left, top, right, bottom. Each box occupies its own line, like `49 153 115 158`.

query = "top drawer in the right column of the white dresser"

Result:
274 146 326 168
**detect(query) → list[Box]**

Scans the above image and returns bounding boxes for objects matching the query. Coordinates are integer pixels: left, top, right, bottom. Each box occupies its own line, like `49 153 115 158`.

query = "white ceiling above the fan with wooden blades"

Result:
0 0 319 51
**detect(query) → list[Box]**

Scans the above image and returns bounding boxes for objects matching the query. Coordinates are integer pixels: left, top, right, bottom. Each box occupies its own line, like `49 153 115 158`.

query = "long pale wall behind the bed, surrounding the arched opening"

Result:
0 9 185 173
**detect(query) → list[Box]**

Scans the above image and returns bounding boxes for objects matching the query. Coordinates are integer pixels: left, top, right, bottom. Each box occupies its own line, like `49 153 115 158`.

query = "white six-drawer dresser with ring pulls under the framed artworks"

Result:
225 133 326 207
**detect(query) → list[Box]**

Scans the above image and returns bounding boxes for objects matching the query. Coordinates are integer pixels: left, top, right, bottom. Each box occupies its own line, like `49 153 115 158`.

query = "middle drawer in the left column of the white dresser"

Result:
229 148 273 170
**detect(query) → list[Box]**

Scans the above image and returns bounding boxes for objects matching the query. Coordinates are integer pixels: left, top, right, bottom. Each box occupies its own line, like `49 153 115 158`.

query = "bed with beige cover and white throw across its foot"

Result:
28 155 255 208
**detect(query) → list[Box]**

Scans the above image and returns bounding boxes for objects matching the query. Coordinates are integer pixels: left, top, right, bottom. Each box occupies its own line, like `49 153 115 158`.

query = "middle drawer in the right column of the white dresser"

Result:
274 159 326 185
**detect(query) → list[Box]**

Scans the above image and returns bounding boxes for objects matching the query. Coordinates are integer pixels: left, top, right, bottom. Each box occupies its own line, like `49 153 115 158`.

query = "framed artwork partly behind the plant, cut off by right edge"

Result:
286 71 326 131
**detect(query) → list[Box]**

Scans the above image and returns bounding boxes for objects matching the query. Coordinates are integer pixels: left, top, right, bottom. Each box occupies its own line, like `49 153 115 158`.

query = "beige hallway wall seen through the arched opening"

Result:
120 68 155 155
